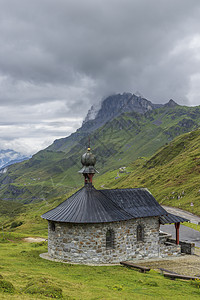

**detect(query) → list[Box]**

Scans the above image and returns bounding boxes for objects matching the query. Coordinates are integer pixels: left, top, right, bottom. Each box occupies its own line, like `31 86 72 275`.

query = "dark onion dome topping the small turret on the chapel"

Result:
79 147 98 174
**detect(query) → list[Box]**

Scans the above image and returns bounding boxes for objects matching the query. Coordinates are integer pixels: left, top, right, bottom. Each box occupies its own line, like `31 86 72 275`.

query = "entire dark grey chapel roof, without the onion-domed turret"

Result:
42 184 167 223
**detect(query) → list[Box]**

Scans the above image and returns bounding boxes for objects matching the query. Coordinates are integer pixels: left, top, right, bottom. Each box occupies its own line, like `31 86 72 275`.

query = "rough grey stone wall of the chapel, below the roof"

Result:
48 217 160 264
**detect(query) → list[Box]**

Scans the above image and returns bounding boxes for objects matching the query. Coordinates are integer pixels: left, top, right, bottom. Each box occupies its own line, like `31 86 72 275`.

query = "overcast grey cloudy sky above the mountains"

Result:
0 0 200 154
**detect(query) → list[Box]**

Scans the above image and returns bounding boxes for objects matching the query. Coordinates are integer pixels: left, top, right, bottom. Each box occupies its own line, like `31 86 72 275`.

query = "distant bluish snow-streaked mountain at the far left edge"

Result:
0 149 30 169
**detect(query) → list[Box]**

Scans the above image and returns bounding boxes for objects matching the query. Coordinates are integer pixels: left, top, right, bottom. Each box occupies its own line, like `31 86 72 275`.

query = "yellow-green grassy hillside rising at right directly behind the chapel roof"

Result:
96 129 200 215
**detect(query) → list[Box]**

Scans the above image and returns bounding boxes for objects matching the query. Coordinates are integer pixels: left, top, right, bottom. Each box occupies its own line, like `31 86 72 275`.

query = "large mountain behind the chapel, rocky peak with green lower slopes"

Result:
0 94 200 203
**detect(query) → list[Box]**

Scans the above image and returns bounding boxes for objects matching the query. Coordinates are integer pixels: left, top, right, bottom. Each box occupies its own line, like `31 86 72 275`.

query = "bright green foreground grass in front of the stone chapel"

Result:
0 234 200 300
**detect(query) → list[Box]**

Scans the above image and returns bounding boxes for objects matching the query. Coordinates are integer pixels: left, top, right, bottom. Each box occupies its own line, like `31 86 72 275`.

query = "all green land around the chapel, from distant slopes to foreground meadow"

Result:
0 94 200 299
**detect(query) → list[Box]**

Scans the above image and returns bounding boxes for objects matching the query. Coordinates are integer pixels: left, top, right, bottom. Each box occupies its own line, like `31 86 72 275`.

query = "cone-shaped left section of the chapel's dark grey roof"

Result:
42 184 133 223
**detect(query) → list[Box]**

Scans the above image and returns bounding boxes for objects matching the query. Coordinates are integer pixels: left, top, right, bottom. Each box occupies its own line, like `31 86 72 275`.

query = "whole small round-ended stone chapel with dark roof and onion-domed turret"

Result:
42 148 187 264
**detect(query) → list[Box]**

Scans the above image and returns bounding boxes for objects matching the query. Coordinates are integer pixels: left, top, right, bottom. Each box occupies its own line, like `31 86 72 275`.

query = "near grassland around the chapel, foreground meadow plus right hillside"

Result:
0 129 200 300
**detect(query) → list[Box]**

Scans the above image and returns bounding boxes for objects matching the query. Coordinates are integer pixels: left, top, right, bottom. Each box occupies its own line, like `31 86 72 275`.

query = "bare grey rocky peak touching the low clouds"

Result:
47 93 164 152
